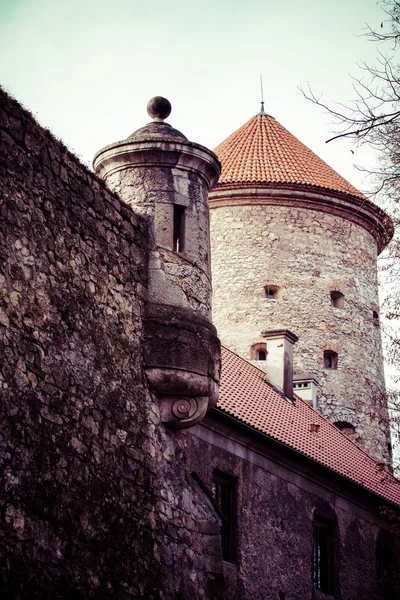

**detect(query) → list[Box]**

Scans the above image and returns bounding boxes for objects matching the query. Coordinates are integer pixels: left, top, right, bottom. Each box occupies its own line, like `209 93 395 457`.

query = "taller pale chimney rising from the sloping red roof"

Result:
262 329 299 400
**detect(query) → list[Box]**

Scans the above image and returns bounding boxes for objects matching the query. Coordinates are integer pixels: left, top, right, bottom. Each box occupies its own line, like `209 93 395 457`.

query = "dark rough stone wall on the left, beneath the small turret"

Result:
0 91 223 600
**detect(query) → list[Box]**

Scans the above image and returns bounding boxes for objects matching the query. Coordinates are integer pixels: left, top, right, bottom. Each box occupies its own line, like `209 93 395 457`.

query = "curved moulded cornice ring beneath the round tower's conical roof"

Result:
210 184 394 254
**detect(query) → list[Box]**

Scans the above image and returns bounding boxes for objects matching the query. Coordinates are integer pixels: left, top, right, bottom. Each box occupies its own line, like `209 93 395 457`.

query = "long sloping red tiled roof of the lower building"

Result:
218 348 400 505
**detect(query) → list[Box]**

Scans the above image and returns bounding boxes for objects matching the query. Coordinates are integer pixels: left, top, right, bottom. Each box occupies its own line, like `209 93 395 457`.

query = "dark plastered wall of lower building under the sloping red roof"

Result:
191 416 400 600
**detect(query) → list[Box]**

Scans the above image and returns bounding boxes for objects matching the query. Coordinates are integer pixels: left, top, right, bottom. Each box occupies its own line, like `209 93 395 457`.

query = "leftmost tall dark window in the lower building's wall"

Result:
212 471 235 562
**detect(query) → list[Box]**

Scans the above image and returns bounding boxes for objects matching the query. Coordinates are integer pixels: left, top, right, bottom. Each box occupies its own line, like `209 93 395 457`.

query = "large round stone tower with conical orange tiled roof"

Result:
210 110 393 463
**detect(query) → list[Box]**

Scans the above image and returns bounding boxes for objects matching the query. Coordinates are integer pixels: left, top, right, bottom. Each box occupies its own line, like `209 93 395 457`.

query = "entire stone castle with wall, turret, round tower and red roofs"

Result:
0 91 400 600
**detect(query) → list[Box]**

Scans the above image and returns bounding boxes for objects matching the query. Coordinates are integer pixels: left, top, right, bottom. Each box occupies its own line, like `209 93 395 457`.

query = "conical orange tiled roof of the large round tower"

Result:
214 114 364 198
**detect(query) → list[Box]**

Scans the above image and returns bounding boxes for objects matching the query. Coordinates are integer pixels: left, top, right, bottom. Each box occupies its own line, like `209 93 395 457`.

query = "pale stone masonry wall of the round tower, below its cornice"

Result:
211 205 390 461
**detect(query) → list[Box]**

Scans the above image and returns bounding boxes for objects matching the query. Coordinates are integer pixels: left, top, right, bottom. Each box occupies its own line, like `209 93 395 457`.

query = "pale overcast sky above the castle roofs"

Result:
0 0 383 188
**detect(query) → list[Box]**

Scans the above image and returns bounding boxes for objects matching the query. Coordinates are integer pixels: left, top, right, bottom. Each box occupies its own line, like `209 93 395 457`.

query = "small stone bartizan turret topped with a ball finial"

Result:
94 96 220 428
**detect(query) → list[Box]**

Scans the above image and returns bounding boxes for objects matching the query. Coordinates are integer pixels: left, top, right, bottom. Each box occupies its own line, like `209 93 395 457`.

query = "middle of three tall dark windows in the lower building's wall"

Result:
313 519 334 594
